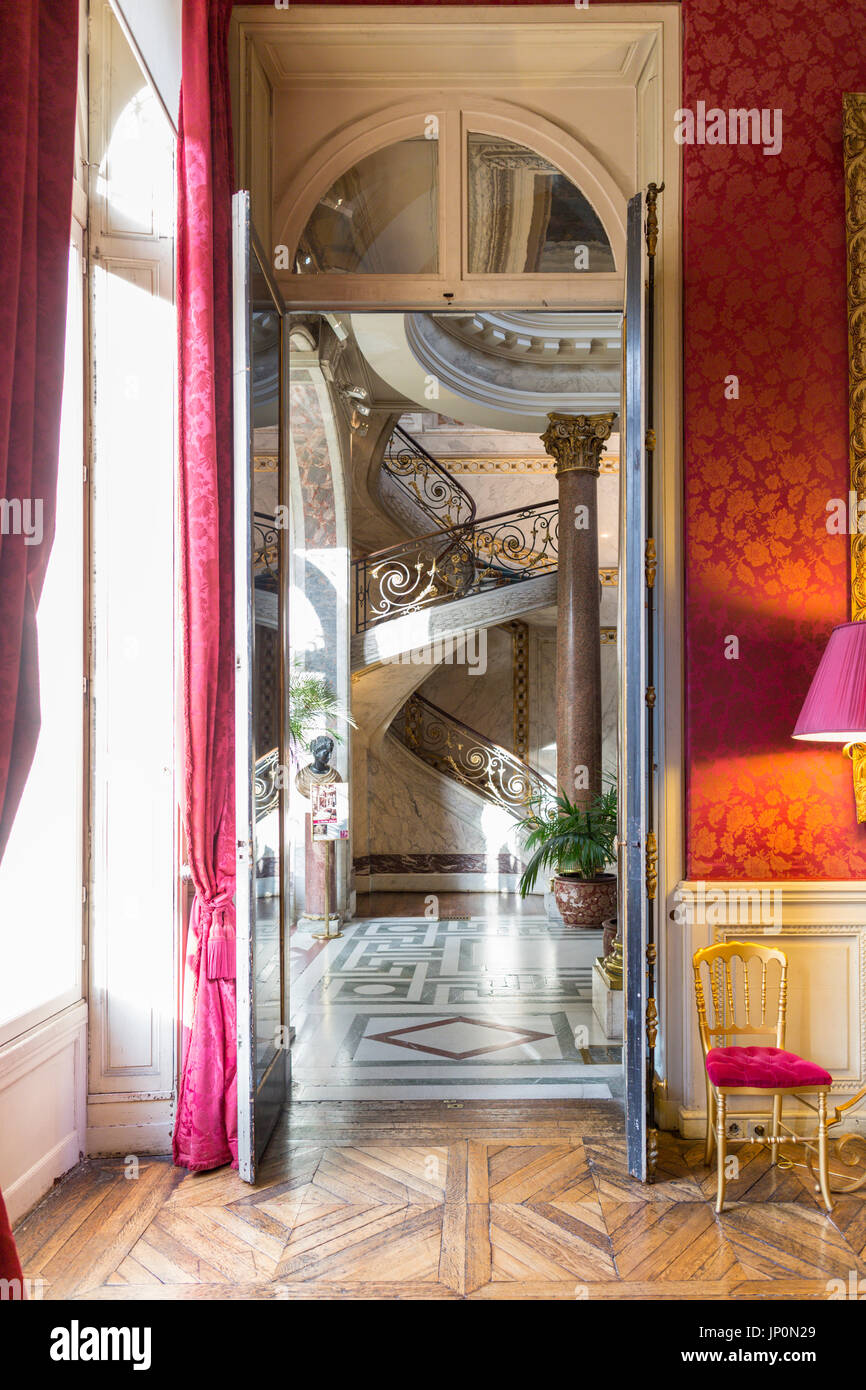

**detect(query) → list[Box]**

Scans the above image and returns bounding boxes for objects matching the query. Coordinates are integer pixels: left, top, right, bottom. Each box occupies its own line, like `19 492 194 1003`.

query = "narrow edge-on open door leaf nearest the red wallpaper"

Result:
619 185 660 1182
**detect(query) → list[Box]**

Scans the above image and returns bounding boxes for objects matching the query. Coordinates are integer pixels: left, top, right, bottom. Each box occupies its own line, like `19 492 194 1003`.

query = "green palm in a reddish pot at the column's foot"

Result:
518 784 617 927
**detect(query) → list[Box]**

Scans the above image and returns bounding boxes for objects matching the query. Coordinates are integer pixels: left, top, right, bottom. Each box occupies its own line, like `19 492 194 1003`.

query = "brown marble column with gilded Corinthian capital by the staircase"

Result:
541 414 616 806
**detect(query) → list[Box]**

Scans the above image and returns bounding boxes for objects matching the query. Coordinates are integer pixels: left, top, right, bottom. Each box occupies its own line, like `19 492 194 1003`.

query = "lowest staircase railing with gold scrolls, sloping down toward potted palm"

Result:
395 695 556 816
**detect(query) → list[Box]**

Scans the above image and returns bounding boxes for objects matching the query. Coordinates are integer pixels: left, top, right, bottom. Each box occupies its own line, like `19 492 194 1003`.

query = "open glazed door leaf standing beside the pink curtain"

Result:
232 193 289 1183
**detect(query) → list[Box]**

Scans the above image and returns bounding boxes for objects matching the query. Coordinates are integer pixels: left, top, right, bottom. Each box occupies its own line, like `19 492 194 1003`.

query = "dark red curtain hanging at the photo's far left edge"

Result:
0 0 78 1280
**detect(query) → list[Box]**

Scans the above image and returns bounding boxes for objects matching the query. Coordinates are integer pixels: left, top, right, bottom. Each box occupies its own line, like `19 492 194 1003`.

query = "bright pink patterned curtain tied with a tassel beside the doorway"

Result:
174 0 238 1169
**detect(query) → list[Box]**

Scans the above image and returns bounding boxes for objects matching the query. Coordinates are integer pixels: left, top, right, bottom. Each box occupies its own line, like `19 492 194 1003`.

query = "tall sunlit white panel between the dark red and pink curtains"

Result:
89 3 177 1104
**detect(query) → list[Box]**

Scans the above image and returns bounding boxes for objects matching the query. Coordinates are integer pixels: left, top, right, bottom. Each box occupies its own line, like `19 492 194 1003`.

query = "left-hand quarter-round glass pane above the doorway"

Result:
295 135 439 275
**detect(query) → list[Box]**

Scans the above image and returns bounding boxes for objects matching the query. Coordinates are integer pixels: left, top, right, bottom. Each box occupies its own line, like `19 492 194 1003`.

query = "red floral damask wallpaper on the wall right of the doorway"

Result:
241 0 866 878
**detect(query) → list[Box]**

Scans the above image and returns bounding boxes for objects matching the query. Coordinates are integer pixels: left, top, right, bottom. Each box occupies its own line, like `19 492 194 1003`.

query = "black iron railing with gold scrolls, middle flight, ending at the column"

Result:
353 500 559 632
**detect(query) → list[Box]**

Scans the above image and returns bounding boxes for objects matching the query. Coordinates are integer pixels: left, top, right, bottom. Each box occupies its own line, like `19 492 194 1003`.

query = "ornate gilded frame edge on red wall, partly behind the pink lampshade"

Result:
844 92 866 821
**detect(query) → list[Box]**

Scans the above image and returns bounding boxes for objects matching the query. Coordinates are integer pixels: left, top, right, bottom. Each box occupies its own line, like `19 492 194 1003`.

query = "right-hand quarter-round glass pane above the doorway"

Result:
467 133 616 275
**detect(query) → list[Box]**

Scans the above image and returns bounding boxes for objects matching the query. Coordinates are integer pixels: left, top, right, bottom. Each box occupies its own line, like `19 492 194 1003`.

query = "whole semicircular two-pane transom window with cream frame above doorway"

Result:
282 110 624 304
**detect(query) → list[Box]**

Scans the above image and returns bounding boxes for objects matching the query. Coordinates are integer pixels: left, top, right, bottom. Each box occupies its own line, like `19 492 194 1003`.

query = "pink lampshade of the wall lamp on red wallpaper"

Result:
794 623 866 744
